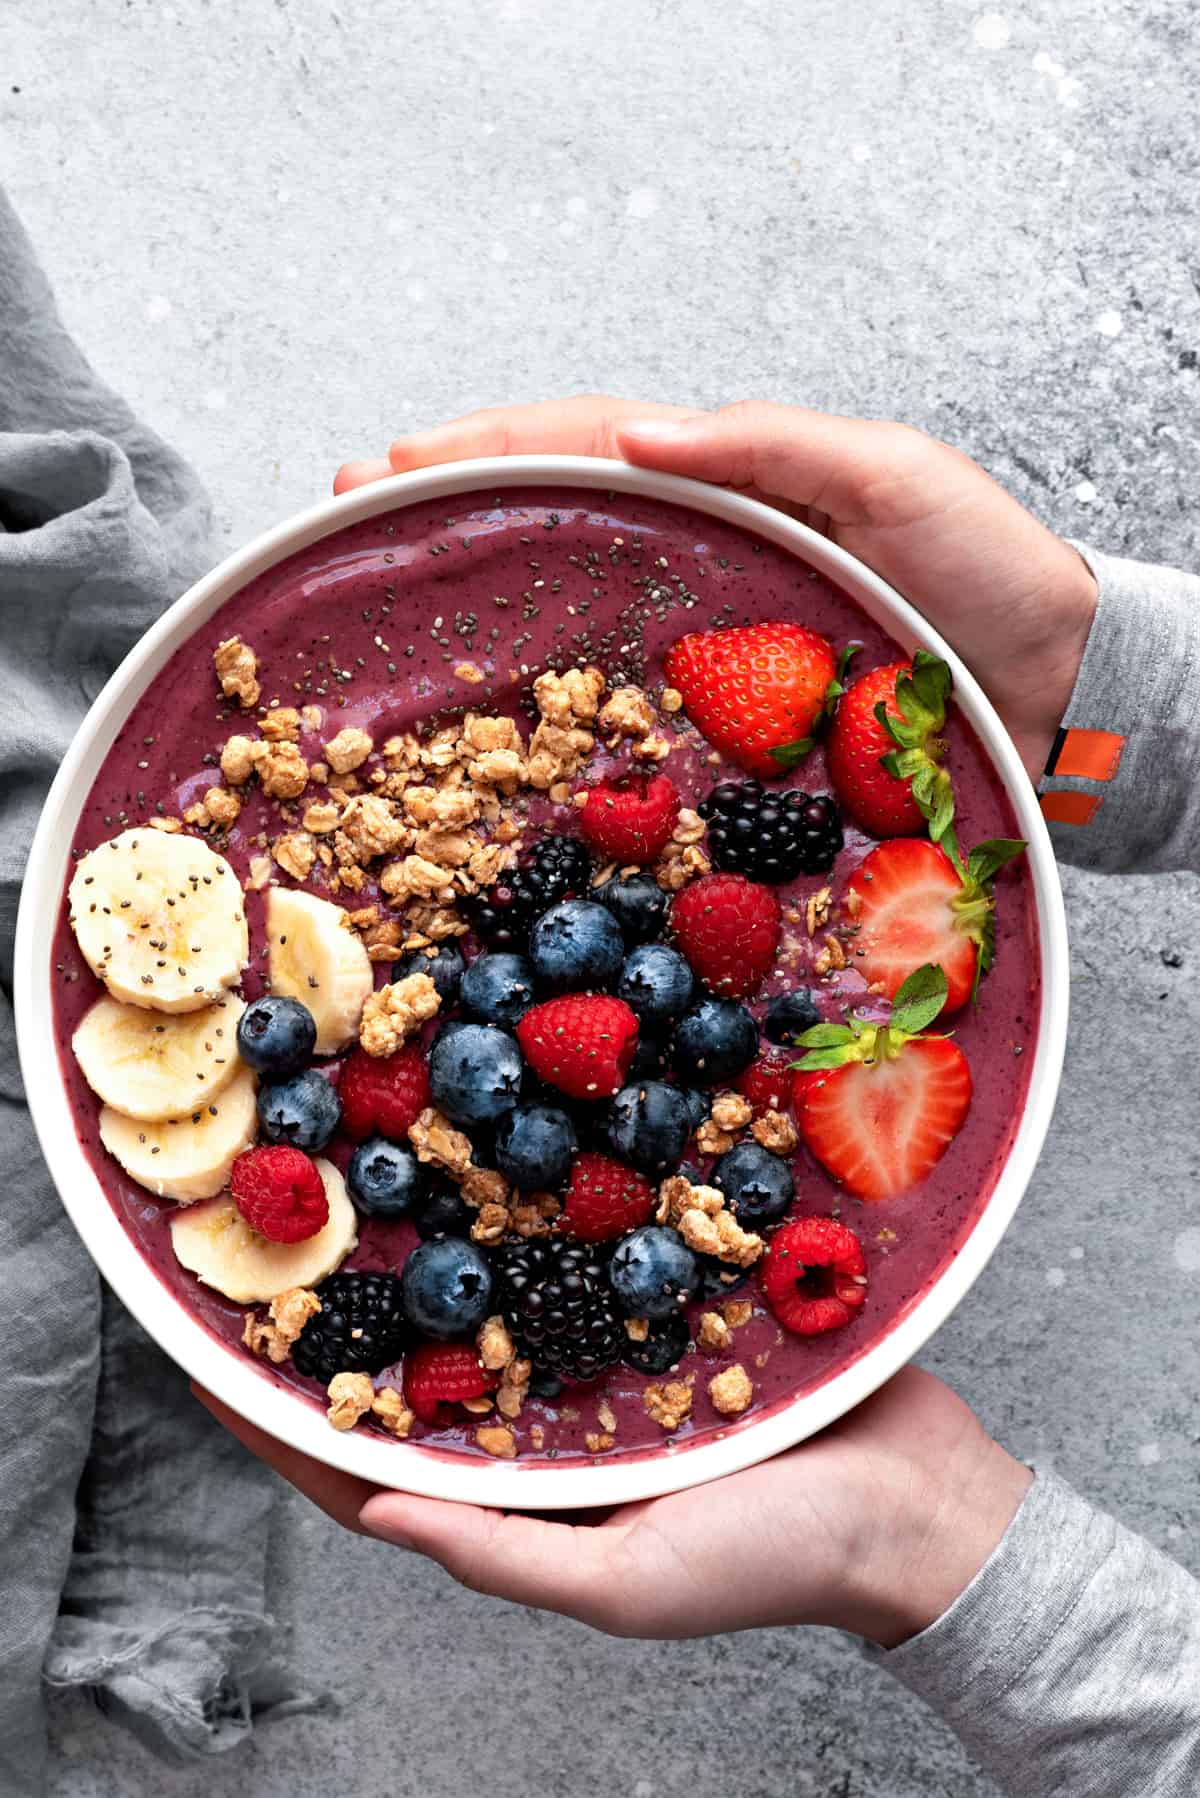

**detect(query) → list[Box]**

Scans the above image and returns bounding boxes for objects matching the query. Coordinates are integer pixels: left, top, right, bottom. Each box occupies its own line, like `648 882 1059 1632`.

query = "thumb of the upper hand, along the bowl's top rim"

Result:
615 401 928 525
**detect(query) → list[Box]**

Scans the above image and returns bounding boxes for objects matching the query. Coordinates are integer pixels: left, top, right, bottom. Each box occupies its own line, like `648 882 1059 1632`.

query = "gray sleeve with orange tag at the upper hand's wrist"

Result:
1042 547 1200 874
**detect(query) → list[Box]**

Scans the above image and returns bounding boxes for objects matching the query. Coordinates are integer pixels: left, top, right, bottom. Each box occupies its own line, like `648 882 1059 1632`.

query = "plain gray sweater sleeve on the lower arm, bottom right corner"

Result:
883 1473 1200 1798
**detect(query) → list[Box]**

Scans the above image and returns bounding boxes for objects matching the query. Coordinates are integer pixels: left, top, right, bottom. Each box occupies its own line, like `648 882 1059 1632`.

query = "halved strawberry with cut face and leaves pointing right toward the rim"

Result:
846 836 1025 1012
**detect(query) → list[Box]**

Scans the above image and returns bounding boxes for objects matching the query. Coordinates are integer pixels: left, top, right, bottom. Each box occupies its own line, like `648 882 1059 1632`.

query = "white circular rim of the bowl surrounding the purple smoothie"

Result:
14 455 1069 1510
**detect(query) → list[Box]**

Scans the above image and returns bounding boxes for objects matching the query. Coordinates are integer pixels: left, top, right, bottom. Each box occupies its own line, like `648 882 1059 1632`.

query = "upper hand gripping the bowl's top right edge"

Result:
335 396 1096 780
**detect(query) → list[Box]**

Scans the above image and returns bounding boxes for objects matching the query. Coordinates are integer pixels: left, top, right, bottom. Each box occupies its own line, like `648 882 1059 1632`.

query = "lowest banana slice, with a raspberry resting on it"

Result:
171 1162 358 1305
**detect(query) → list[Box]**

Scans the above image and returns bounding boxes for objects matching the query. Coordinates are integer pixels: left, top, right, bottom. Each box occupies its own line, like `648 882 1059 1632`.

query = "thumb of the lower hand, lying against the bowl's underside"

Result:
360 1492 621 1629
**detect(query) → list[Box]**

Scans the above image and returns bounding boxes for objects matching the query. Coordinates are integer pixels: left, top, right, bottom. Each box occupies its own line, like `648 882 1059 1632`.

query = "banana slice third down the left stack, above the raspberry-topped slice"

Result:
101 1068 259 1205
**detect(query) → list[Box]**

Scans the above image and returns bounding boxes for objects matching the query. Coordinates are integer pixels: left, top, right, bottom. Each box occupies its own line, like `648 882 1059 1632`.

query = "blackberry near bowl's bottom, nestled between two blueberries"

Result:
493 1237 626 1379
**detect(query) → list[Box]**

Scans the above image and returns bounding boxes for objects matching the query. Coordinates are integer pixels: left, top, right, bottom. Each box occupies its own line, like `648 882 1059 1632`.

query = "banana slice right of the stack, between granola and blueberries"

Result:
266 886 374 1055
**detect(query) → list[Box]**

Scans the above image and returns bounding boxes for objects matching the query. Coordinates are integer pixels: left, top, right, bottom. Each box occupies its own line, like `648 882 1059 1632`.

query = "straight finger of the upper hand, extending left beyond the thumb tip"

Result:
389 394 689 475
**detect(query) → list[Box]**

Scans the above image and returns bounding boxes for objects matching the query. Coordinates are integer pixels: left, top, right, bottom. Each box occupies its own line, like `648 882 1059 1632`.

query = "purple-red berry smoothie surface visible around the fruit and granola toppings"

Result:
52 489 1040 1480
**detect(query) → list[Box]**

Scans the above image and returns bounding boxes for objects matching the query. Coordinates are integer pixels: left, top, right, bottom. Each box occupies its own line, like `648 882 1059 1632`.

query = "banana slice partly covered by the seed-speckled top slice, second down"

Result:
70 992 246 1120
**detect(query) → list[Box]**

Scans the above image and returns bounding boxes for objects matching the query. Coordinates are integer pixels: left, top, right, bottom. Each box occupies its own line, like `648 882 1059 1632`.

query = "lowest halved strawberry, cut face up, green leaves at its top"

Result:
792 966 972 1199
